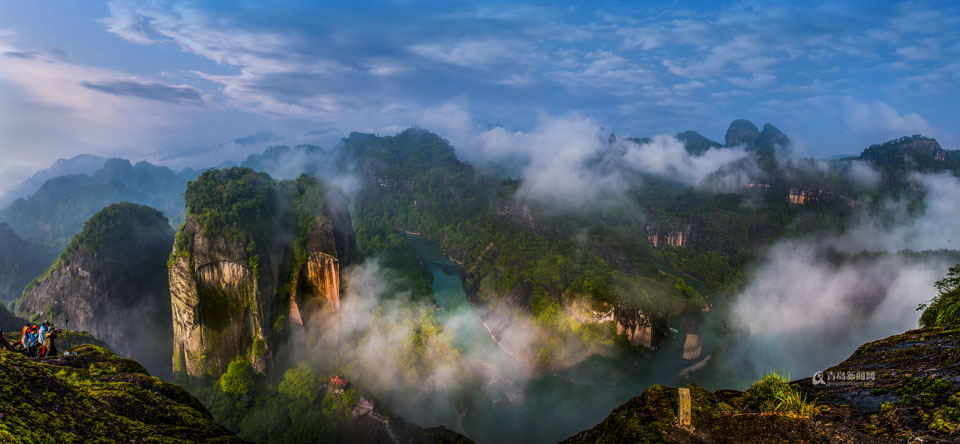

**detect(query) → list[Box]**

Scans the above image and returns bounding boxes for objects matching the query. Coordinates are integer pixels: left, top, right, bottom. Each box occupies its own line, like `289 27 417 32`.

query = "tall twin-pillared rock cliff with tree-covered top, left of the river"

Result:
169 168 352 377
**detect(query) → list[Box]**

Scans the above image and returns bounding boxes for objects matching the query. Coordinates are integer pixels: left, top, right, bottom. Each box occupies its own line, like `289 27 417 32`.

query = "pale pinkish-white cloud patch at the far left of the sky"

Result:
0 40 217 176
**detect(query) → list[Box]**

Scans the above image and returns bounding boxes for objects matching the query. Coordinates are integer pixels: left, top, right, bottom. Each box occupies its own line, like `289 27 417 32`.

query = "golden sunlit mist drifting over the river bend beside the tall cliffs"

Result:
305 259 531 429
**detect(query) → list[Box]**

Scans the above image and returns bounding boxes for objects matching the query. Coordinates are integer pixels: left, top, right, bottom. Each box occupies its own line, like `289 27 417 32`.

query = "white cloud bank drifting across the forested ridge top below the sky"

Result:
420 103 746 210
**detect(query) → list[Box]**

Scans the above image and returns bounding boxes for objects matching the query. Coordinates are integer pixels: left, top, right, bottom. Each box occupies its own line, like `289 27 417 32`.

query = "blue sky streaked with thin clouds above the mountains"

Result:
0 0 960 190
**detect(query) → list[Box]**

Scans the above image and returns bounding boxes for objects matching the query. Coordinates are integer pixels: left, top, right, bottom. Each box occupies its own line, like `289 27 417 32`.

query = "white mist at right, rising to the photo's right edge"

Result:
724 172 960 378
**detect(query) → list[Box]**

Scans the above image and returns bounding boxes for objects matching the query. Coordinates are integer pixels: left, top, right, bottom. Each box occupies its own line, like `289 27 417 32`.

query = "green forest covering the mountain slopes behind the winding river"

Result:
341 127 853 367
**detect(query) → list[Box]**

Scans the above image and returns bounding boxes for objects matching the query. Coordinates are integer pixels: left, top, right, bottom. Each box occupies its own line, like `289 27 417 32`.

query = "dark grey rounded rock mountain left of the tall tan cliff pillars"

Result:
15 203 173 373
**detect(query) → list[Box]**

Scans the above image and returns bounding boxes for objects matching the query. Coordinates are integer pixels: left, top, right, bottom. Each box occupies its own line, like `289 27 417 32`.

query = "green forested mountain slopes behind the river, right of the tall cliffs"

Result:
328 121 911 368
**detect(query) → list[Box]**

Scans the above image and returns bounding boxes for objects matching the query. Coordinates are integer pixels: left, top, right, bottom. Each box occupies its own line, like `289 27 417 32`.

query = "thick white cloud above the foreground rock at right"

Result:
724 239 952 378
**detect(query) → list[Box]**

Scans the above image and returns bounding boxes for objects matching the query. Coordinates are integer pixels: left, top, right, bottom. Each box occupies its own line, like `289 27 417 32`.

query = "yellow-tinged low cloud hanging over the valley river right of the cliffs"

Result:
306 259 608 433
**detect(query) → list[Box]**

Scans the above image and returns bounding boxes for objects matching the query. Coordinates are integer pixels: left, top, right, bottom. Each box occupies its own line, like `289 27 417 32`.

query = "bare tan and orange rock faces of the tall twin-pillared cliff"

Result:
169 215 348 377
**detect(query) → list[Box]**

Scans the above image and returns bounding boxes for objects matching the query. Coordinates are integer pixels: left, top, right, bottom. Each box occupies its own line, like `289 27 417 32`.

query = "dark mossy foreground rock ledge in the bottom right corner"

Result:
564 328 960 444
